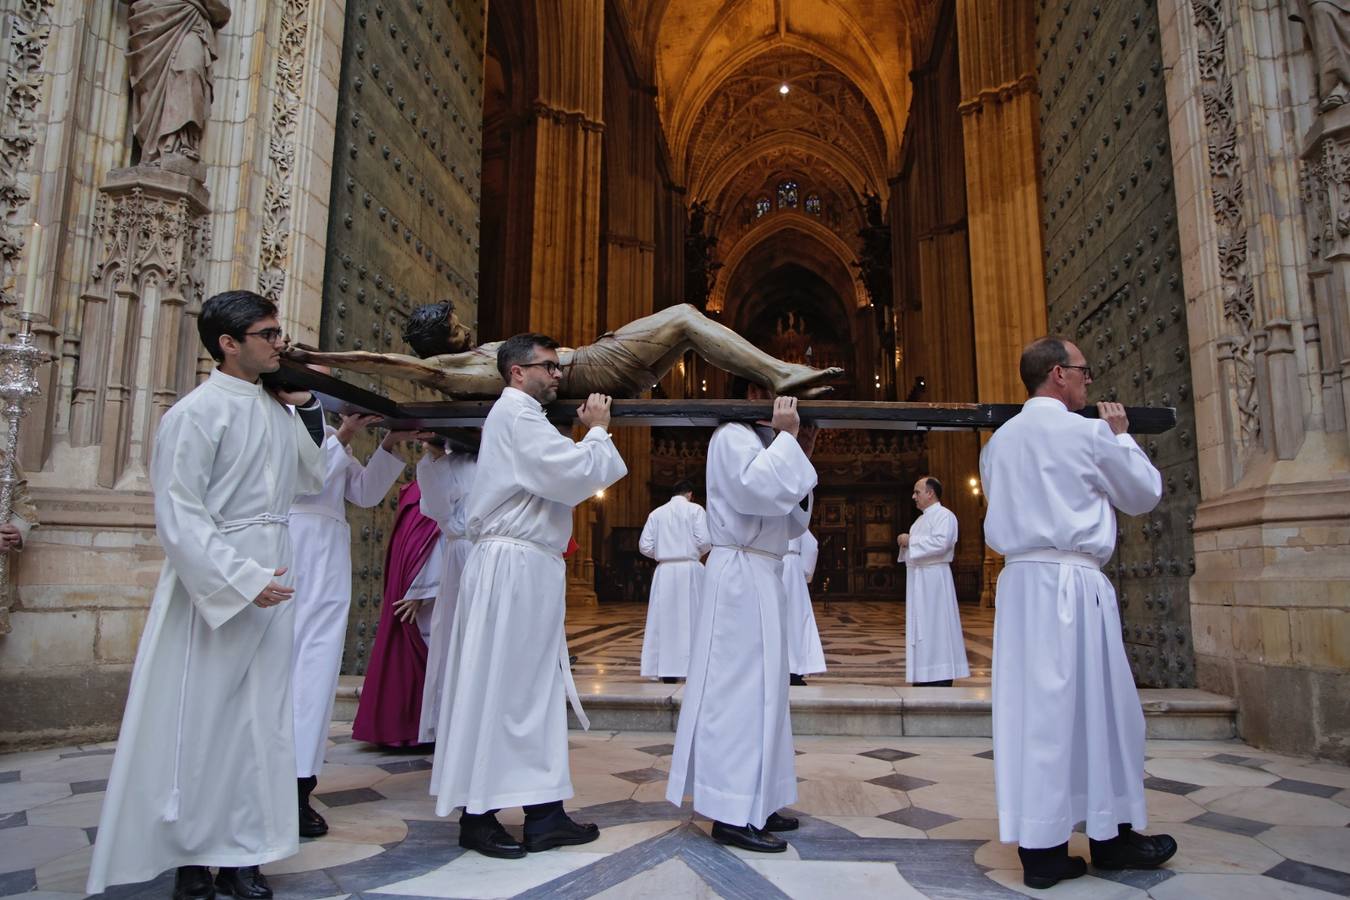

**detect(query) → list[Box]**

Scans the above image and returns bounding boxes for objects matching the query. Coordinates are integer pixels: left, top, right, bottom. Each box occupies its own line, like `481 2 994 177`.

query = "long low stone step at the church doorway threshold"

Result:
333 676 1238 741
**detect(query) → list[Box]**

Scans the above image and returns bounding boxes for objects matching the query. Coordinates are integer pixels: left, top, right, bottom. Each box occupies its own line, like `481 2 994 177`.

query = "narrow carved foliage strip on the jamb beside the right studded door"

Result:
1191 0 1261 449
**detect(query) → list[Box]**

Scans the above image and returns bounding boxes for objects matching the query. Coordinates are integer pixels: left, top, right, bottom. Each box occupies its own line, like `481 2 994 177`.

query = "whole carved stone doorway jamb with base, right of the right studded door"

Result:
1158 0 1350 761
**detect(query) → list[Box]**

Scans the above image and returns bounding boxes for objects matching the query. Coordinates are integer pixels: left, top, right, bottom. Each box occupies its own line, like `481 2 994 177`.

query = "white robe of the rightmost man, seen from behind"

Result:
980 397 1162 847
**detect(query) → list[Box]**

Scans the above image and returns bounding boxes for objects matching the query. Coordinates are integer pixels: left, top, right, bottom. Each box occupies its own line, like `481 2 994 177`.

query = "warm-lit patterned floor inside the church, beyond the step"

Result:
567 600 994 687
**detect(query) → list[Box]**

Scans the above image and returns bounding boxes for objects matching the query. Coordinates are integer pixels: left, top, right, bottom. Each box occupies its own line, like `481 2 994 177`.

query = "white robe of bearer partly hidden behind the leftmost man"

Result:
290 426 404 779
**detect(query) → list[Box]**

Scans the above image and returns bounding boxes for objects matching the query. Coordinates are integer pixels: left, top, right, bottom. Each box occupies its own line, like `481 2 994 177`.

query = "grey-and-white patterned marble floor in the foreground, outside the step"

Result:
0 725 1350 900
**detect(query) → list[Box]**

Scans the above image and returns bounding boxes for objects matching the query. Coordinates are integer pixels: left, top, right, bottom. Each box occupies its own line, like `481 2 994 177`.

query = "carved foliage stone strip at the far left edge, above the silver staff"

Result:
0 0 55 304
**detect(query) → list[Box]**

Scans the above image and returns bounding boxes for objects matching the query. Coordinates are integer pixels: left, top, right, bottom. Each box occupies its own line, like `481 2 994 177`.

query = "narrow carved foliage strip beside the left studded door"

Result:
258 0 309 301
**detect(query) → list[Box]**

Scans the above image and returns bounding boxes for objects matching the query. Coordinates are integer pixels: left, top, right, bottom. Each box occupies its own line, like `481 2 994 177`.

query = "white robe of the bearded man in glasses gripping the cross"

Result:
431 387 628 815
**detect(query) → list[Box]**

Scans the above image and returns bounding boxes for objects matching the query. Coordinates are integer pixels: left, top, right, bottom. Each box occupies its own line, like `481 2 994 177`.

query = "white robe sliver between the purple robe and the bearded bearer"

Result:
417 451 477 743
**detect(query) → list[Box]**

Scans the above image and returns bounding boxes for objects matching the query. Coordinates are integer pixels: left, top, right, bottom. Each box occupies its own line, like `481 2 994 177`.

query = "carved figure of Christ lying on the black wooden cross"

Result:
288 302 844 399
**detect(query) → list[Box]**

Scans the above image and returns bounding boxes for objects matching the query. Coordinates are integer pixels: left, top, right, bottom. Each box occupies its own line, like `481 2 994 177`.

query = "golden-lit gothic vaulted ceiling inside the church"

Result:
620 0 937 322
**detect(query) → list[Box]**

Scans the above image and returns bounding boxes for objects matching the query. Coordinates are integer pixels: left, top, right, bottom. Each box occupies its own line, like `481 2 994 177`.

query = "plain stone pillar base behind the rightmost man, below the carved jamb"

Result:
1191 469 1350 764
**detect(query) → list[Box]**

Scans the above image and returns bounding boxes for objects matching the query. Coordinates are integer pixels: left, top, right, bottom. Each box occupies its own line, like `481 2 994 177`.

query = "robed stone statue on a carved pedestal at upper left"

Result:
127 0 230 170
